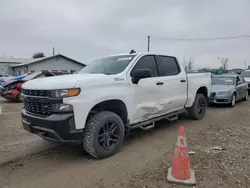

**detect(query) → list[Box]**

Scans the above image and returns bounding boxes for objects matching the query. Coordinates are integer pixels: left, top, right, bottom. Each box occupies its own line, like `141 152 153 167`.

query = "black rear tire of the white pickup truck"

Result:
188 94 207 120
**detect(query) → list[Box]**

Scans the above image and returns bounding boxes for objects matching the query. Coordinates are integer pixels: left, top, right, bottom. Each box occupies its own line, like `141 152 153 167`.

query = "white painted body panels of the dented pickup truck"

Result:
23 53 211 129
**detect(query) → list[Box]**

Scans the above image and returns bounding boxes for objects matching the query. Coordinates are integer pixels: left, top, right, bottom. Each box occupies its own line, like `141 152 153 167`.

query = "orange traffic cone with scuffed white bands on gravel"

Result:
167 126 196 185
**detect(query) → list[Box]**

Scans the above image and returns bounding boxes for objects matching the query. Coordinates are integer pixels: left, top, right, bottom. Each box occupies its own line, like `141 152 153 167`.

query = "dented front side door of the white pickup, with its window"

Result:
129 55 163 124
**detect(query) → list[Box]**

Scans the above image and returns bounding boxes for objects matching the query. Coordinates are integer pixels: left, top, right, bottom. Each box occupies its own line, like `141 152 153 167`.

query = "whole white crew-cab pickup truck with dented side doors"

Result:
21 53 211 158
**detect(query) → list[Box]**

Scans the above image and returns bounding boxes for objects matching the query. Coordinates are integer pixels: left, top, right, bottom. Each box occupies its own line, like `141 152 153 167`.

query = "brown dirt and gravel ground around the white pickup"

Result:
0 97 250 188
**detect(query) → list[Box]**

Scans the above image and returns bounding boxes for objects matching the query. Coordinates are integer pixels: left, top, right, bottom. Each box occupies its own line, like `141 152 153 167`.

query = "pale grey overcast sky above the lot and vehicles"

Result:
0 0 250 68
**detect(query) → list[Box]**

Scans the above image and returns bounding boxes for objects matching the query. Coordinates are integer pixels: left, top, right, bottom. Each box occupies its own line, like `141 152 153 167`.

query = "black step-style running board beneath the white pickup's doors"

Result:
130 109 185 130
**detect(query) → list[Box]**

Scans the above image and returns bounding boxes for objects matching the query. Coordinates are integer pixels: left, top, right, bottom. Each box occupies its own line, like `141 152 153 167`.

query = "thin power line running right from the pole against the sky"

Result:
150 35 250 41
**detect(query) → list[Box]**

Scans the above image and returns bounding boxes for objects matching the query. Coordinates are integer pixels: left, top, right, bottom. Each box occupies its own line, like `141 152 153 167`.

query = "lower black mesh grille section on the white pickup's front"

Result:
24 99 52 116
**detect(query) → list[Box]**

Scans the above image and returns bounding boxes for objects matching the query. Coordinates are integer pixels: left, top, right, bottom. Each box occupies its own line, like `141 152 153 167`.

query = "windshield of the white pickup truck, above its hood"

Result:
79 55 135 75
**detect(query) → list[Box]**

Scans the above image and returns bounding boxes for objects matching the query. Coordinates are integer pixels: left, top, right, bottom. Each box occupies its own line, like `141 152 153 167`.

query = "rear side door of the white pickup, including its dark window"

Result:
156 55 187 113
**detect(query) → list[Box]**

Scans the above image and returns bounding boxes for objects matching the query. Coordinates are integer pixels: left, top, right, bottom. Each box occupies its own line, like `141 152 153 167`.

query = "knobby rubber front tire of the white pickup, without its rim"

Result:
82 111 125 159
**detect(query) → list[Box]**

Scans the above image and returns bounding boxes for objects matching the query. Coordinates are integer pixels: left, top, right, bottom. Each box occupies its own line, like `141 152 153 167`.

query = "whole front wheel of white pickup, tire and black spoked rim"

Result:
82 111 125 159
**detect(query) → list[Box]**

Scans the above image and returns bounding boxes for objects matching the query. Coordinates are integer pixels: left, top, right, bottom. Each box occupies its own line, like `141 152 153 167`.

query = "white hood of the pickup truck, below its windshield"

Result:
22 74 114 90
